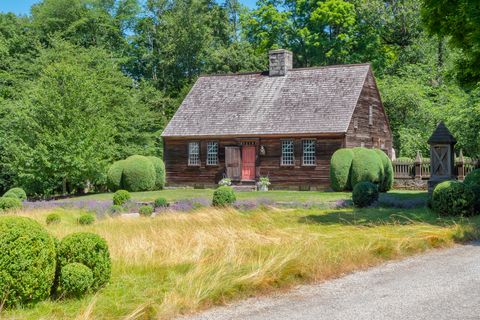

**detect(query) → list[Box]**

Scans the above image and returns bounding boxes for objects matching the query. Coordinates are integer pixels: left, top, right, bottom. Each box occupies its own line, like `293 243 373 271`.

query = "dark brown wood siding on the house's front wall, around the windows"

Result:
164 136 344 189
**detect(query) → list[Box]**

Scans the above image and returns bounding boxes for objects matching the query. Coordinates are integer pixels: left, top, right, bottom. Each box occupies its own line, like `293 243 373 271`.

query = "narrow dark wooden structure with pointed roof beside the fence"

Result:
428 122 457 194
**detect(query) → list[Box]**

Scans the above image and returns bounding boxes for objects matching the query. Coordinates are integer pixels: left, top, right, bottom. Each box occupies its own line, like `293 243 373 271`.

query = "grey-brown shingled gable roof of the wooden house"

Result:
162 64 370 137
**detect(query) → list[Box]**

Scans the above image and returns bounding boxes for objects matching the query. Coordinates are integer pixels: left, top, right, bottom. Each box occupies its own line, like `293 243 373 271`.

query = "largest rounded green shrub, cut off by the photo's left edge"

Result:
0 217 56 308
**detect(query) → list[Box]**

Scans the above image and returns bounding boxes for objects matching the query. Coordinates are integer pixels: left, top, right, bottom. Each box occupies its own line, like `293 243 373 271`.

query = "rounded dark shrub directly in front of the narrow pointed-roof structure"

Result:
432 180 475 216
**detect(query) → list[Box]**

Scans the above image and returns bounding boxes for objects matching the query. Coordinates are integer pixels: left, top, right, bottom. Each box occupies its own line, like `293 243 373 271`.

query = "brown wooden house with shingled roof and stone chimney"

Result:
162 50 392 189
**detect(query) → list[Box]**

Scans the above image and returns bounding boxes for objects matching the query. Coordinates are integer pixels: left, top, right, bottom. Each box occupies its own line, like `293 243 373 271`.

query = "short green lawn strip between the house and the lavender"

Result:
69 189 427 203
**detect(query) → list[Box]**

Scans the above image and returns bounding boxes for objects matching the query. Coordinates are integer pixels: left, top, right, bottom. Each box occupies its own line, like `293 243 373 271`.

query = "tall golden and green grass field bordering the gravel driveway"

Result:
4 196 480 319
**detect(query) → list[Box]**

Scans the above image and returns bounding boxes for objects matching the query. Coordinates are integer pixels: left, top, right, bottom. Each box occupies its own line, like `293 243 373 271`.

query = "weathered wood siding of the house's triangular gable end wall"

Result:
345 71 392 157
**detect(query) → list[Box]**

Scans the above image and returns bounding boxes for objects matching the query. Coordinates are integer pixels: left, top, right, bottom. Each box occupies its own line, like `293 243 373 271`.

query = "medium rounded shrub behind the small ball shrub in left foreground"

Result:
57 232 112 291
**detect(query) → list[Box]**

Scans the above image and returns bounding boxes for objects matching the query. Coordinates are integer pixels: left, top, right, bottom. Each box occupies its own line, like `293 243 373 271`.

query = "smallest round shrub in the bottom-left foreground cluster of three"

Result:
58 262 93 298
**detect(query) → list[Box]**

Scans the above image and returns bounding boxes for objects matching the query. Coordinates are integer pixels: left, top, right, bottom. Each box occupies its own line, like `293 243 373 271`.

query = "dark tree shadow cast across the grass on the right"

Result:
299 207 470 227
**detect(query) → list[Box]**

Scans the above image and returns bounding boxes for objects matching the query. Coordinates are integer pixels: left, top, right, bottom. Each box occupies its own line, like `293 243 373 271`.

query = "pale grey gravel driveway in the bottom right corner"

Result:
184 242 480 320
